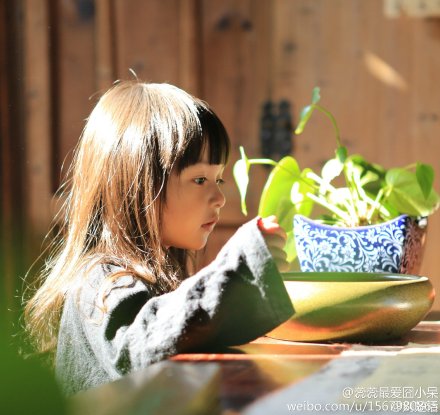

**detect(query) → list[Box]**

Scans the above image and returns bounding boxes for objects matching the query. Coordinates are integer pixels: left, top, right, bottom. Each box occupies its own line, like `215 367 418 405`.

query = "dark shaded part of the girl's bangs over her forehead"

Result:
176 106 230 173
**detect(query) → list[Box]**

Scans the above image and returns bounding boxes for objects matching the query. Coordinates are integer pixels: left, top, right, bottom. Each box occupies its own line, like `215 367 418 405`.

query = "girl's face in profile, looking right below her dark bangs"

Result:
161 156 226 250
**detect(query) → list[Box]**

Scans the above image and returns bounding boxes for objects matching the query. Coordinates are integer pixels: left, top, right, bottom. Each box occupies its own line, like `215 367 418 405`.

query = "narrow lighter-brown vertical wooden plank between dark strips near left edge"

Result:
23 0 52 239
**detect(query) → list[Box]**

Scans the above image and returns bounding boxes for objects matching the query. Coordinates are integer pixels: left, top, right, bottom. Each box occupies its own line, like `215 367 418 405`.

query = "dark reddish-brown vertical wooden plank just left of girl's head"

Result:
53 1 96 183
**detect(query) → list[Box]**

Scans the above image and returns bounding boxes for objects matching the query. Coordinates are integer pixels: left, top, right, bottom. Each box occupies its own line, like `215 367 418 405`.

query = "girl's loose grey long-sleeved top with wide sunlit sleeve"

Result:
56 220 293 395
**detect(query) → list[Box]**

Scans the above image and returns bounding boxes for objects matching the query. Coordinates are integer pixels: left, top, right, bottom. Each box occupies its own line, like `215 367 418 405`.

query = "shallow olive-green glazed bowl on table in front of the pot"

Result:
267 272 435 343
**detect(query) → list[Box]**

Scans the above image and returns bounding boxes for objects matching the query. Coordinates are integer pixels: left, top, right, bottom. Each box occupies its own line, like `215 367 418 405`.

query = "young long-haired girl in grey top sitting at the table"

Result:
25 81 293 394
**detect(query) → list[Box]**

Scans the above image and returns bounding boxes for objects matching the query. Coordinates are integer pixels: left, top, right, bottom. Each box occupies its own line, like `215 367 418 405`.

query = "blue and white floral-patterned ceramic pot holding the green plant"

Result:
293 215 427 275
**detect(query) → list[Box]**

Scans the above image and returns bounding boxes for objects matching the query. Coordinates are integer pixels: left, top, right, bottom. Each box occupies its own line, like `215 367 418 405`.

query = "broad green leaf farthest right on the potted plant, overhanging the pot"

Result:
385 168 440 216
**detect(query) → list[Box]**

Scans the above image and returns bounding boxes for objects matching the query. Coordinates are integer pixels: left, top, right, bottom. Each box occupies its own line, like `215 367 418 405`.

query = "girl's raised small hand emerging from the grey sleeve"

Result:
258 216 289 272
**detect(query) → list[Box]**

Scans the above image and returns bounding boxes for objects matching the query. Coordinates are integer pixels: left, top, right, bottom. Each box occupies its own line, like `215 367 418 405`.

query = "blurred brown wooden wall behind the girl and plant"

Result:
0 0 440 334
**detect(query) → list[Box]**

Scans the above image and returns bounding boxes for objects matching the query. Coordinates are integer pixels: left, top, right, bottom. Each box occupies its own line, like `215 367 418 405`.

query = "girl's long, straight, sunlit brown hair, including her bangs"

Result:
24 81 229 358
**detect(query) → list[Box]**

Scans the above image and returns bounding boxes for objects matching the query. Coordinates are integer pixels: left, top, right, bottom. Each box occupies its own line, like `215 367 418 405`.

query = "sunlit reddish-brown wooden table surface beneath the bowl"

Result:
71 313 440 415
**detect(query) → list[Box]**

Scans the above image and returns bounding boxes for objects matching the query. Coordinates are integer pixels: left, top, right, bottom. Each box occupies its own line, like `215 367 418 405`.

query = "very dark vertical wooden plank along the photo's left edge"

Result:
0 0 30 322
